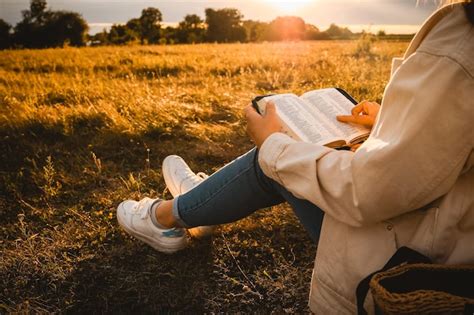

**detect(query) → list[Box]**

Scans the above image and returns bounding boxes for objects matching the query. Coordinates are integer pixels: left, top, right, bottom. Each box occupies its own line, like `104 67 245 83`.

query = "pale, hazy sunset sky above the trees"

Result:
0 0 437 33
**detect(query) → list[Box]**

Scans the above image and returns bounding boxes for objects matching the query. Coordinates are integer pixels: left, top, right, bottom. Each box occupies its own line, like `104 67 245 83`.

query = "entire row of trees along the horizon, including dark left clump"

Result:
0 0 357 49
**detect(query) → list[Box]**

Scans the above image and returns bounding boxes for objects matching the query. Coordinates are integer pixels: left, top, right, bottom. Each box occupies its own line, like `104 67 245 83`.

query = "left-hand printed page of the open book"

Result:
258 94 343 145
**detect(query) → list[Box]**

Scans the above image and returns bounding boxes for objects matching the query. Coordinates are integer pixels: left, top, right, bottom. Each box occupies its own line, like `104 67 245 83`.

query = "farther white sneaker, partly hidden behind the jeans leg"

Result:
162 155 215 238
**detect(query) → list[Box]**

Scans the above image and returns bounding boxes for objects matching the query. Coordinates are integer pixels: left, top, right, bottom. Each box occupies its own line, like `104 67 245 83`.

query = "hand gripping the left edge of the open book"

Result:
244 102 282 148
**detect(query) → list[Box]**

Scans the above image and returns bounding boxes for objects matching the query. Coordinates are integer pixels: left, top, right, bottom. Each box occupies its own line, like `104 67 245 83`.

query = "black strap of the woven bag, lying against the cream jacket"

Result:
356 246 431 315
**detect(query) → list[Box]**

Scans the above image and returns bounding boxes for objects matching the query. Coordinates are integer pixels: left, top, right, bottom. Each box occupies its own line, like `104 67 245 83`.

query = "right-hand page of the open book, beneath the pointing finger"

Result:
301 88 370 143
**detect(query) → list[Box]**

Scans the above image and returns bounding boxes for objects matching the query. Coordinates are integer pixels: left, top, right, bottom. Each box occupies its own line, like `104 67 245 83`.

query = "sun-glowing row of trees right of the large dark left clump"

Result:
90 8 357 45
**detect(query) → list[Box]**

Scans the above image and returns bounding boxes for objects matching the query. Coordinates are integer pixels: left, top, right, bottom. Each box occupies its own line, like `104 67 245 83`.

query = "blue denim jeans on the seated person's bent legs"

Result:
173 149 324 243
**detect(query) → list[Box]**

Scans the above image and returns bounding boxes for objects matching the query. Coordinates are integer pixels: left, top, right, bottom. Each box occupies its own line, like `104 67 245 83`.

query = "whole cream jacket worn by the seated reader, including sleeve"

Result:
259 4 474 314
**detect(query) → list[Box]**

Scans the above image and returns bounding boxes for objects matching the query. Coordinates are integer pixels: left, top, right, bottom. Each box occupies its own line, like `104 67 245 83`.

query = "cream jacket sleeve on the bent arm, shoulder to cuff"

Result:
259 53 474 226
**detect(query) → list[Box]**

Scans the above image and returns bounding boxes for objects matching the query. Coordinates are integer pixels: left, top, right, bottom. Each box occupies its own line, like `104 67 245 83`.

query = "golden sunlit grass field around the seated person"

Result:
0 42 407 313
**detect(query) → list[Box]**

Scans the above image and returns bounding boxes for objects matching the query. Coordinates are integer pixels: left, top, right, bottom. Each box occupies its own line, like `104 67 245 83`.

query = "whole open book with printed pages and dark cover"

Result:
252 88 370 148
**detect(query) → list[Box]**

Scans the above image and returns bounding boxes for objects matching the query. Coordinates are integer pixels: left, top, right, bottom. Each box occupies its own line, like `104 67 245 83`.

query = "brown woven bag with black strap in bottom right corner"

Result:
356 247 474 315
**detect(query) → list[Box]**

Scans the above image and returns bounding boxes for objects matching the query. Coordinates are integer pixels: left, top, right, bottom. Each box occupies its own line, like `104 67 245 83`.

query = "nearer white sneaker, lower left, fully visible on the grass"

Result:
117 198 188 253
